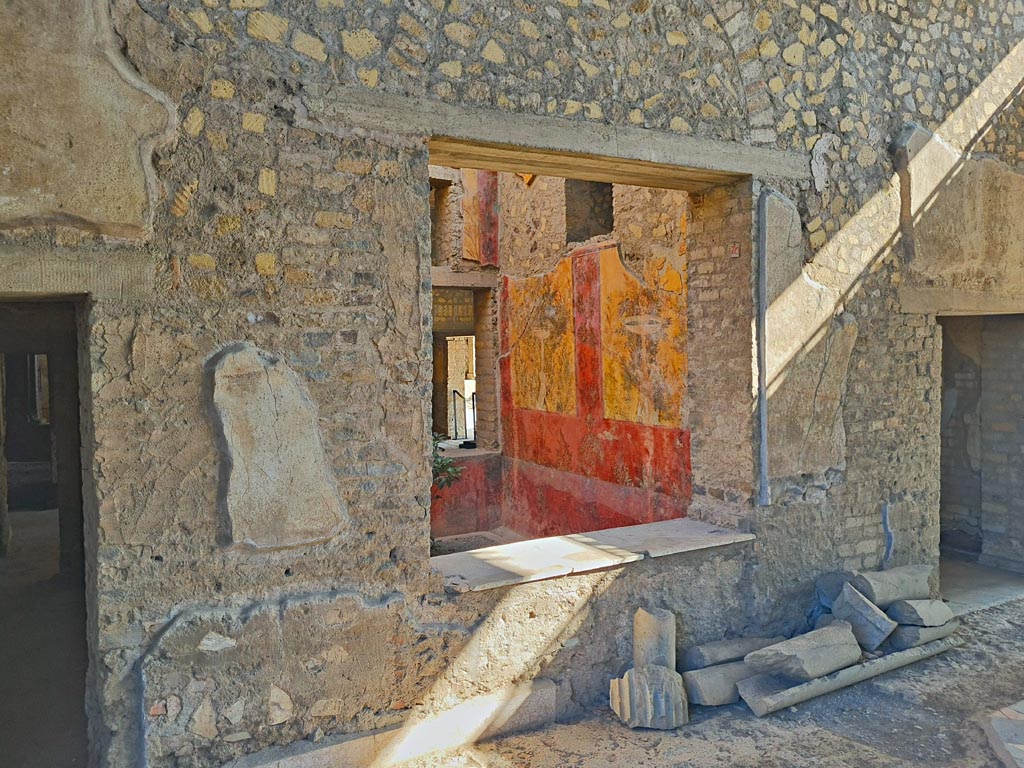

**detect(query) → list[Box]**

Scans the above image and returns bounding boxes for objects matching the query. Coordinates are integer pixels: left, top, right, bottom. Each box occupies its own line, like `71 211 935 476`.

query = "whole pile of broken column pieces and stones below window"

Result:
611 565 959 728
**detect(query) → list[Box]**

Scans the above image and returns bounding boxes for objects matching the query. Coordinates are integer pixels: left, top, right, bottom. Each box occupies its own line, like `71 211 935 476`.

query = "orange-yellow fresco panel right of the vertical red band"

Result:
600 247 686 427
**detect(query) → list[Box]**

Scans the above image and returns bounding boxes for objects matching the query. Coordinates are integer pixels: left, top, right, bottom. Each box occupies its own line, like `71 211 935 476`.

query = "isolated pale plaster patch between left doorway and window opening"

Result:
207 343 348 547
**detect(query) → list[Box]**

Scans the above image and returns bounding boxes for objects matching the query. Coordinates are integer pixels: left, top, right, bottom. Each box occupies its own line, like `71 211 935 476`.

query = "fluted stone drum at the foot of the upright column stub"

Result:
609 665 689 730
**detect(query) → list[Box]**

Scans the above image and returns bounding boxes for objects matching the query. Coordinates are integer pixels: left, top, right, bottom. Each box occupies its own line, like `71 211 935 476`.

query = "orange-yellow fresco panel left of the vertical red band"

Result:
508 259 577 414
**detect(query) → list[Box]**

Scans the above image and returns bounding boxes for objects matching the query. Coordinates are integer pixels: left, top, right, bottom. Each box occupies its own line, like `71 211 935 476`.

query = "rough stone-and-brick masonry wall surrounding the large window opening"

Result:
4 0 1024 765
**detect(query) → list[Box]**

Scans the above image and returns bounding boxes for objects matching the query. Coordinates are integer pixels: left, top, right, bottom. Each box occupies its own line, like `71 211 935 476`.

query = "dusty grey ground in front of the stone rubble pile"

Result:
401 600 1024 768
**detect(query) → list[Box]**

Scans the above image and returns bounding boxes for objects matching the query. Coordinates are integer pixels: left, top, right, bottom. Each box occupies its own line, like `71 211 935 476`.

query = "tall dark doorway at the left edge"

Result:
0 302 88 768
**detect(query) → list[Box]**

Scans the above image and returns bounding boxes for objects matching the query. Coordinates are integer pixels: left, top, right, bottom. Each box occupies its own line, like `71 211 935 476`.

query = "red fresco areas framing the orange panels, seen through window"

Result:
500 244 691 537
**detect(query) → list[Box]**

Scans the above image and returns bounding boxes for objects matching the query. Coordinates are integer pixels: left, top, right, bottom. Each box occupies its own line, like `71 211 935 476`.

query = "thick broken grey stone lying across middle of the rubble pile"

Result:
740 621 860 692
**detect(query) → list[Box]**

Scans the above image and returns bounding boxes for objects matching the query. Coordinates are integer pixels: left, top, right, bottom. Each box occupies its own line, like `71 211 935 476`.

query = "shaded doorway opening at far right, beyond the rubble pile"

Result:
939 314 1024 612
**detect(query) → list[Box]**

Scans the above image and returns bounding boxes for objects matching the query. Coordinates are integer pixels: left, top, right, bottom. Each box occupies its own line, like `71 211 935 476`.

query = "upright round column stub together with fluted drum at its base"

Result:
608 608 689 730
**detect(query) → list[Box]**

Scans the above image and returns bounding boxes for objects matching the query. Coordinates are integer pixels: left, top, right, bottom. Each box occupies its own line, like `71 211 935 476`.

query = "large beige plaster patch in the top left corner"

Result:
0 0 176 238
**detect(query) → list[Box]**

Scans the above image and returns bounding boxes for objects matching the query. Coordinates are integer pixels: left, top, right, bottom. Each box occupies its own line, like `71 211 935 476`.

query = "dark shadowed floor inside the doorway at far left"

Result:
0 510 86 768
